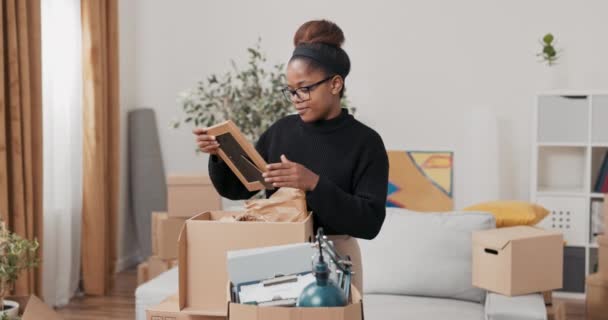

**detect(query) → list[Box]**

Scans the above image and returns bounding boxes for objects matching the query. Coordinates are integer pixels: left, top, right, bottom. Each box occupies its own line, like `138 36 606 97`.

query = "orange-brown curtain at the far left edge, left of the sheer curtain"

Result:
0 0 43 295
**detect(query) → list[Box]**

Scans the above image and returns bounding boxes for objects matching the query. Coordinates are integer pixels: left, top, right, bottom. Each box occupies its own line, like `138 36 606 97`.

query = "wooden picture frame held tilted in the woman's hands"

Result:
207 120 274 191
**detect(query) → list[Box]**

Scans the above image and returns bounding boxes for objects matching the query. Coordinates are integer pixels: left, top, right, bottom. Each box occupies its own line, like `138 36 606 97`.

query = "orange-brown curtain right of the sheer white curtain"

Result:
81 0 120 295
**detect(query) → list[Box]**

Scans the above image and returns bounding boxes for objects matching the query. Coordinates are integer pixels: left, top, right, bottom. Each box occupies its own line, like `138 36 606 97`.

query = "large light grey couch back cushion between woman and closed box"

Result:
358 208 495 302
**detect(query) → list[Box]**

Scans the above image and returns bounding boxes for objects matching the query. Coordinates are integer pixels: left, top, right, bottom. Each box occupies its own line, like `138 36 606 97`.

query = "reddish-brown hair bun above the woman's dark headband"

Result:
293 20 344 48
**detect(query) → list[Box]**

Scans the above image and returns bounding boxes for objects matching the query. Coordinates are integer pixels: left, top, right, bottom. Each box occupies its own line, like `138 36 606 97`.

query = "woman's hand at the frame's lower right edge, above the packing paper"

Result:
263 155 319 191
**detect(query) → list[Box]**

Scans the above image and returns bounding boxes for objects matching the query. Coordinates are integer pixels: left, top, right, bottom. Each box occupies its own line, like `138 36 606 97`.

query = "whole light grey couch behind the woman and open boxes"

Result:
135 208 546 320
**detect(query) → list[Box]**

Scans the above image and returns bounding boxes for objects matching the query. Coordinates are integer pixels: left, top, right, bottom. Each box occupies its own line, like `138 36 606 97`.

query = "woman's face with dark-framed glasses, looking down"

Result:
286 59 343 122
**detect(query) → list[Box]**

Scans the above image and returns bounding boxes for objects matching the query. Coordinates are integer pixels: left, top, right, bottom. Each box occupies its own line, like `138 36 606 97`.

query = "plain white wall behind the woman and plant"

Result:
116 0 608 264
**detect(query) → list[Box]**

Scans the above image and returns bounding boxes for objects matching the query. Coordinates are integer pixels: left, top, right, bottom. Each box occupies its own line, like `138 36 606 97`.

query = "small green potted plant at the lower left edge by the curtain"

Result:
0 221 39 320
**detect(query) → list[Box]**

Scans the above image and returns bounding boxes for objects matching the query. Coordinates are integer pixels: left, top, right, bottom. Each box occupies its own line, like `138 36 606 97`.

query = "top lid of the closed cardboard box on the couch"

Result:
473 226 559 250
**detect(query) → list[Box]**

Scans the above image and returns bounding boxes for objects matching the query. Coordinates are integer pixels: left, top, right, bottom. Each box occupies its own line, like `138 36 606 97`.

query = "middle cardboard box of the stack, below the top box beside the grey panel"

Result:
152 212 186 260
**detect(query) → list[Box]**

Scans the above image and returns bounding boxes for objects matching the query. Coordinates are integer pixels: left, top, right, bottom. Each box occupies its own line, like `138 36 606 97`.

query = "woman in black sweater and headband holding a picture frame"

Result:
194 20 388 292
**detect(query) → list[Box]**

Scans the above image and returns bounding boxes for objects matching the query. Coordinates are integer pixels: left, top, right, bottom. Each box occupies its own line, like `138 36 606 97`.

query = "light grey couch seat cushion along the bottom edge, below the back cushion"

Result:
363 294 484 320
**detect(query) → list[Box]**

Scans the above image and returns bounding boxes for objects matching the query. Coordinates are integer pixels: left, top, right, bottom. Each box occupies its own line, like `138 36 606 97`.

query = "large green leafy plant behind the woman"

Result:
173 39 356 147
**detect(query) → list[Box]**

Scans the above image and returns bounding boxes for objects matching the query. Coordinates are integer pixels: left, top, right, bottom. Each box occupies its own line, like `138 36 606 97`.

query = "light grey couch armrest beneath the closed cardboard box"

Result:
484 292 547 320
